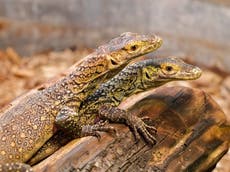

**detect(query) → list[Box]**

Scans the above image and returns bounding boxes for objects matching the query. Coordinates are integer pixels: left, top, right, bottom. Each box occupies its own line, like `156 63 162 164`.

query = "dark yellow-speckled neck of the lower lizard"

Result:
80 63 142 113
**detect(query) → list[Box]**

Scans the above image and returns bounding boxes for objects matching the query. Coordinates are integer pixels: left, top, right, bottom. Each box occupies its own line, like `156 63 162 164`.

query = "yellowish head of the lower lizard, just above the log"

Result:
142 57 202 86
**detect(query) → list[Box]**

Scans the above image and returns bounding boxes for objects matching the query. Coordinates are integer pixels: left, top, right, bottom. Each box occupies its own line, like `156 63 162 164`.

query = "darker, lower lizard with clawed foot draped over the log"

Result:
56 57 201 144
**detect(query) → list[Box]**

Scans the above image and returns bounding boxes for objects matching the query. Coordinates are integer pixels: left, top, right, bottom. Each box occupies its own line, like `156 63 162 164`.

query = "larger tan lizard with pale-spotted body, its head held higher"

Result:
0 32 162 171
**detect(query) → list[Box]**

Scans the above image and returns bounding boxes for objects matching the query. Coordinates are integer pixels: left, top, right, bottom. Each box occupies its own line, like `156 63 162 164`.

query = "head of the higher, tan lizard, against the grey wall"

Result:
97 32 162 68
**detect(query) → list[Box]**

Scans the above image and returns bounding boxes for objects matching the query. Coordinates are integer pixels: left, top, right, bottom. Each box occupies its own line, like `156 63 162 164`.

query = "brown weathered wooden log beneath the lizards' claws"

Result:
34 86 230 172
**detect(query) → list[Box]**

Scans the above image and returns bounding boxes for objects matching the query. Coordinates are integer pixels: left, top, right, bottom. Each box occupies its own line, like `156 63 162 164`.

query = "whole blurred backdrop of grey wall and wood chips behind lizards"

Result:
0 0 230 172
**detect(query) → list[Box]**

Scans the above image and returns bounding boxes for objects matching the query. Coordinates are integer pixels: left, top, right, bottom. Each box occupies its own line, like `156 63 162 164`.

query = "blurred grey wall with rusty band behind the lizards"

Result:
0 0 230 71
